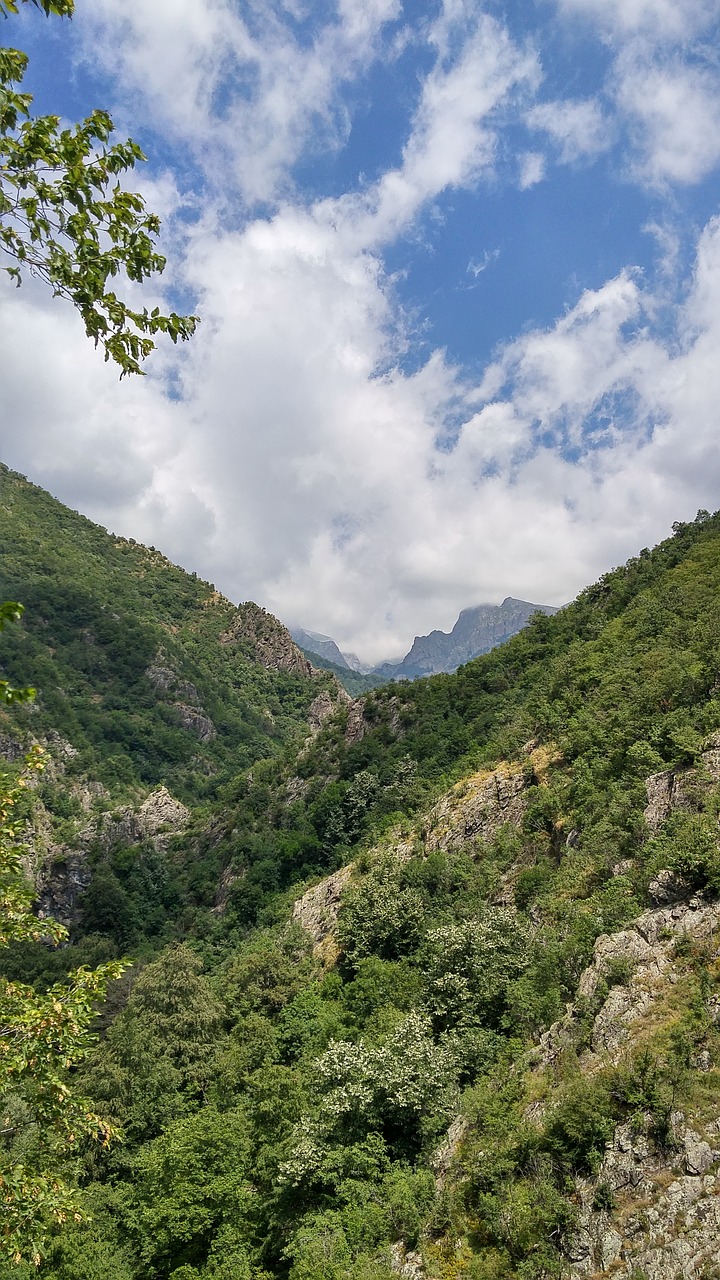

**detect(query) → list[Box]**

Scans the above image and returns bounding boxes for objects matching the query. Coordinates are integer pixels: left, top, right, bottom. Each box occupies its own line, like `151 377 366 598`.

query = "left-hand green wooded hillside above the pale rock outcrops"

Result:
0 468 323 799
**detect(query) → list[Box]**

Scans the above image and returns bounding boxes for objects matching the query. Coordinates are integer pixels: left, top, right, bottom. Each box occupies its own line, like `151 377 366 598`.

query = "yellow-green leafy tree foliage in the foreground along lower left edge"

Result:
0 604 126 1265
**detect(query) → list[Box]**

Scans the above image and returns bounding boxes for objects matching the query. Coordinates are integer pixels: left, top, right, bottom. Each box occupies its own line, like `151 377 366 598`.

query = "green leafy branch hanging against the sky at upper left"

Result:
0 0 197 378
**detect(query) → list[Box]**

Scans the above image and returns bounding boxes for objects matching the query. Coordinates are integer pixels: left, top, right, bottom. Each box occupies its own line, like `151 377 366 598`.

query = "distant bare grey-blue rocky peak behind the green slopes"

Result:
373 595 557 680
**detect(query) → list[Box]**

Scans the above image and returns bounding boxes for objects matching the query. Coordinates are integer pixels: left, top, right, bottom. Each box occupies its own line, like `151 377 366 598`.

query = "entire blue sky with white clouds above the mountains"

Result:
0 0 720 662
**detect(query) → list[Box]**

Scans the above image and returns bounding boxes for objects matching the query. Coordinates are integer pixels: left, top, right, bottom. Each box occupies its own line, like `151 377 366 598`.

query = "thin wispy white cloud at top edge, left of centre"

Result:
77 0 400 204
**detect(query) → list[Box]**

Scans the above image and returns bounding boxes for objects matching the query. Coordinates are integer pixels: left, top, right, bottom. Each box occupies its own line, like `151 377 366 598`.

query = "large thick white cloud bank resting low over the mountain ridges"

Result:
3 211 720 658
